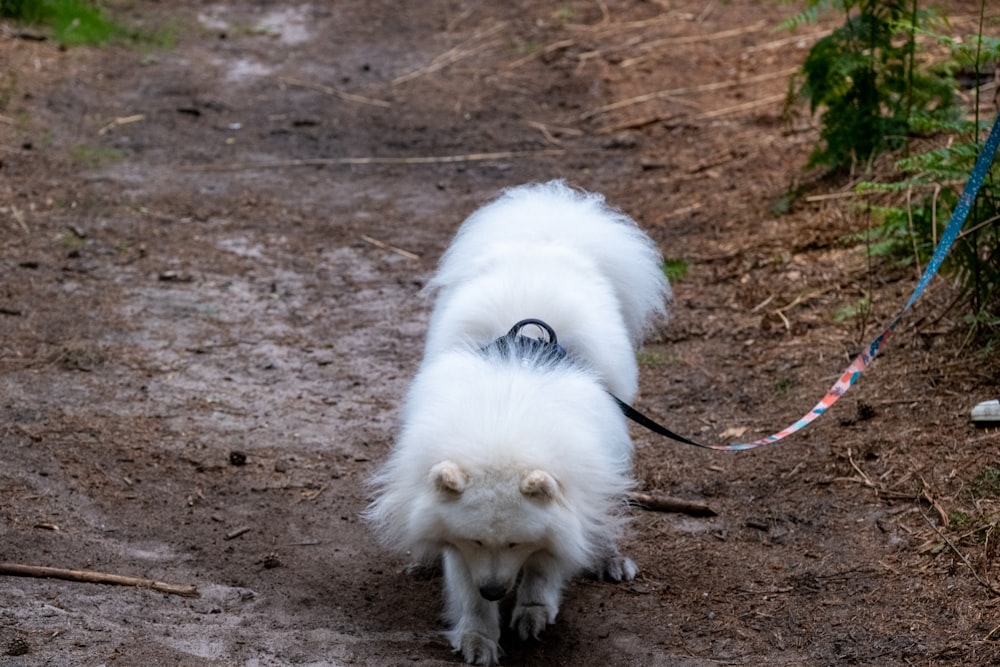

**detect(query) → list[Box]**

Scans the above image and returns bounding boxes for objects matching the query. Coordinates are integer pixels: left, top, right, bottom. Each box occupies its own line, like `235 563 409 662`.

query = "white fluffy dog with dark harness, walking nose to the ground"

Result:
366 181 670 665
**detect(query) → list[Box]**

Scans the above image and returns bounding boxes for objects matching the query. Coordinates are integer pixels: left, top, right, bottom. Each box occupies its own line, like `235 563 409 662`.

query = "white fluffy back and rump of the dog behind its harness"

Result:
425 181 670 400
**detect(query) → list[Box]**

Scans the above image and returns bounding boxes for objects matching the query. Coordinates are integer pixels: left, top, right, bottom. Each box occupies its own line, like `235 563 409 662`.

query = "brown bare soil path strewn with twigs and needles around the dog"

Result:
0 0 1000 667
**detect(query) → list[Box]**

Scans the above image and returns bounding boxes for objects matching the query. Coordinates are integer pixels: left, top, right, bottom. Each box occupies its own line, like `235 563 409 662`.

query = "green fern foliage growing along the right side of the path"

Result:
782 0 1000 340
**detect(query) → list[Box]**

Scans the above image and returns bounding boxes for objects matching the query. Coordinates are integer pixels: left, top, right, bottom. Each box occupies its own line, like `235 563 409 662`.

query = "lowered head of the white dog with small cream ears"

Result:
429 461 563 601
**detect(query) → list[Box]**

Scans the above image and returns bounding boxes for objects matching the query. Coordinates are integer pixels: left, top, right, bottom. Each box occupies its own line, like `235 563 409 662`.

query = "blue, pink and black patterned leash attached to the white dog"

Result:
628 114 1000 452
